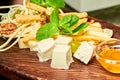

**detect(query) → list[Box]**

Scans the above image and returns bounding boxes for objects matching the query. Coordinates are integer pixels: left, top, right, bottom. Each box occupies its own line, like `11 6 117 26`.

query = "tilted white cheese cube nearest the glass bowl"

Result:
73 41 95 64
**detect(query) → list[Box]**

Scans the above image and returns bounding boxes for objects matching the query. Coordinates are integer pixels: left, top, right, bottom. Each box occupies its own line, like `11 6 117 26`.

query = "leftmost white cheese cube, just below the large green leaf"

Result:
35 38 55 62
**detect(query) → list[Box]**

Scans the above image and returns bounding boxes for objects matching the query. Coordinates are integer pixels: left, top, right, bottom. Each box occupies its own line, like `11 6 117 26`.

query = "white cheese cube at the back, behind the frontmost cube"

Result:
55 36 72 45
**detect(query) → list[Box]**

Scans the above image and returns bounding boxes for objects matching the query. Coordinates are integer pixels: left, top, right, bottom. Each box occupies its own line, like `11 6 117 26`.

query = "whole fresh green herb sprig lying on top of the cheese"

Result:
30 0 87 40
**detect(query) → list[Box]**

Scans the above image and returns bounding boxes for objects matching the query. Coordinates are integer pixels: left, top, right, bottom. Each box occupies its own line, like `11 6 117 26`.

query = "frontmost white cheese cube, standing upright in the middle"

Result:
51 45 73 69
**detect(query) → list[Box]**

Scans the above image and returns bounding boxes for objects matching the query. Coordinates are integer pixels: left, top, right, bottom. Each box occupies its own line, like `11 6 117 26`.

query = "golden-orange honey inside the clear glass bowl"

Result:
97 49 120 73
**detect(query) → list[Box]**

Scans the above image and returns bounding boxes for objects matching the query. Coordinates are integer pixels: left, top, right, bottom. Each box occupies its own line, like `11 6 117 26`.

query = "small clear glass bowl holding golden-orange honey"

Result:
95 40 120 73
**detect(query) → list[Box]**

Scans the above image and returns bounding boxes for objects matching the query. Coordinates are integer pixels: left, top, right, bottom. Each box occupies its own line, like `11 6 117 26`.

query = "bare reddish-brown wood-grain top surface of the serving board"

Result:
0 17 120 80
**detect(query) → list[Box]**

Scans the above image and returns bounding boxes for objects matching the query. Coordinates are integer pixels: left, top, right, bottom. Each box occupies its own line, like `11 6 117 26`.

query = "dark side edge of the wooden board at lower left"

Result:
0 64 39 80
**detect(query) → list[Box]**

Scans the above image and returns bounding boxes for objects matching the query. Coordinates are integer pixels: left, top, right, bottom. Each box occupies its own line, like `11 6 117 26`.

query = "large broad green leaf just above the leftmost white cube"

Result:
36 23 58 40
